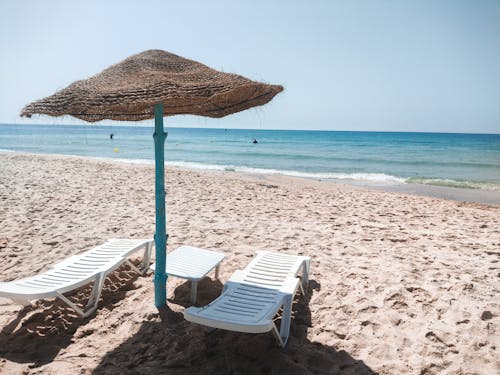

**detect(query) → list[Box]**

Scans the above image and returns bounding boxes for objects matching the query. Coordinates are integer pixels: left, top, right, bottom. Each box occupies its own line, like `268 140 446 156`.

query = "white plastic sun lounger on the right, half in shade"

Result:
184 251 310 347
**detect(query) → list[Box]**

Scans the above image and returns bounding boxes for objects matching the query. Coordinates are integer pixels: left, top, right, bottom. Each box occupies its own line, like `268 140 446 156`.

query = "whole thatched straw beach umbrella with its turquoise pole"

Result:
21 50 283 307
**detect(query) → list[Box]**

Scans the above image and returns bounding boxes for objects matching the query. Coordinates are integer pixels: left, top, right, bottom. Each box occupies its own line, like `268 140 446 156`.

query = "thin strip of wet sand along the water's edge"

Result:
0 150 500 206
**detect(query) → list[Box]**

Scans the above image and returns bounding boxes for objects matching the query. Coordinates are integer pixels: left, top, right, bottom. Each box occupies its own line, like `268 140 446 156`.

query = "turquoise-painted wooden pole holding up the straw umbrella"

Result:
153 104 168 307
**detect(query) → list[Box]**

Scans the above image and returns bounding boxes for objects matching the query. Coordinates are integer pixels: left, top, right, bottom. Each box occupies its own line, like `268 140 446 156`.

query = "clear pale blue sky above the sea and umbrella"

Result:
0 0 500 133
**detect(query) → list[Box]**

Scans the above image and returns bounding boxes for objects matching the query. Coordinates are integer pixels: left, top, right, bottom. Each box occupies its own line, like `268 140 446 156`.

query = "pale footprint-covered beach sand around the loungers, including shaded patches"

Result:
0 153 500 374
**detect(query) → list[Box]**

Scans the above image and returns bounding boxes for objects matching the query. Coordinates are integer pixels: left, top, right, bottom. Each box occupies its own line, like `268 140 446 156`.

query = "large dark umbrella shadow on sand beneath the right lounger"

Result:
94 280 373 374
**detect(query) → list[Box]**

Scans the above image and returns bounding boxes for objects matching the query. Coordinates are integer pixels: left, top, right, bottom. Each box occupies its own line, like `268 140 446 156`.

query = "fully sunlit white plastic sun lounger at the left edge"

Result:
0 239 153 317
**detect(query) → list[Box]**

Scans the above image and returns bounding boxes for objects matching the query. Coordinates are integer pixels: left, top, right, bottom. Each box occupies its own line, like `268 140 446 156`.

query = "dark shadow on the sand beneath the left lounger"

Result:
0 266 143 367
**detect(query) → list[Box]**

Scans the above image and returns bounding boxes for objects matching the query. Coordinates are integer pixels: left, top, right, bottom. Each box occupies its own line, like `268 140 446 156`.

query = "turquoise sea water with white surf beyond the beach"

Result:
0 125 500 191
